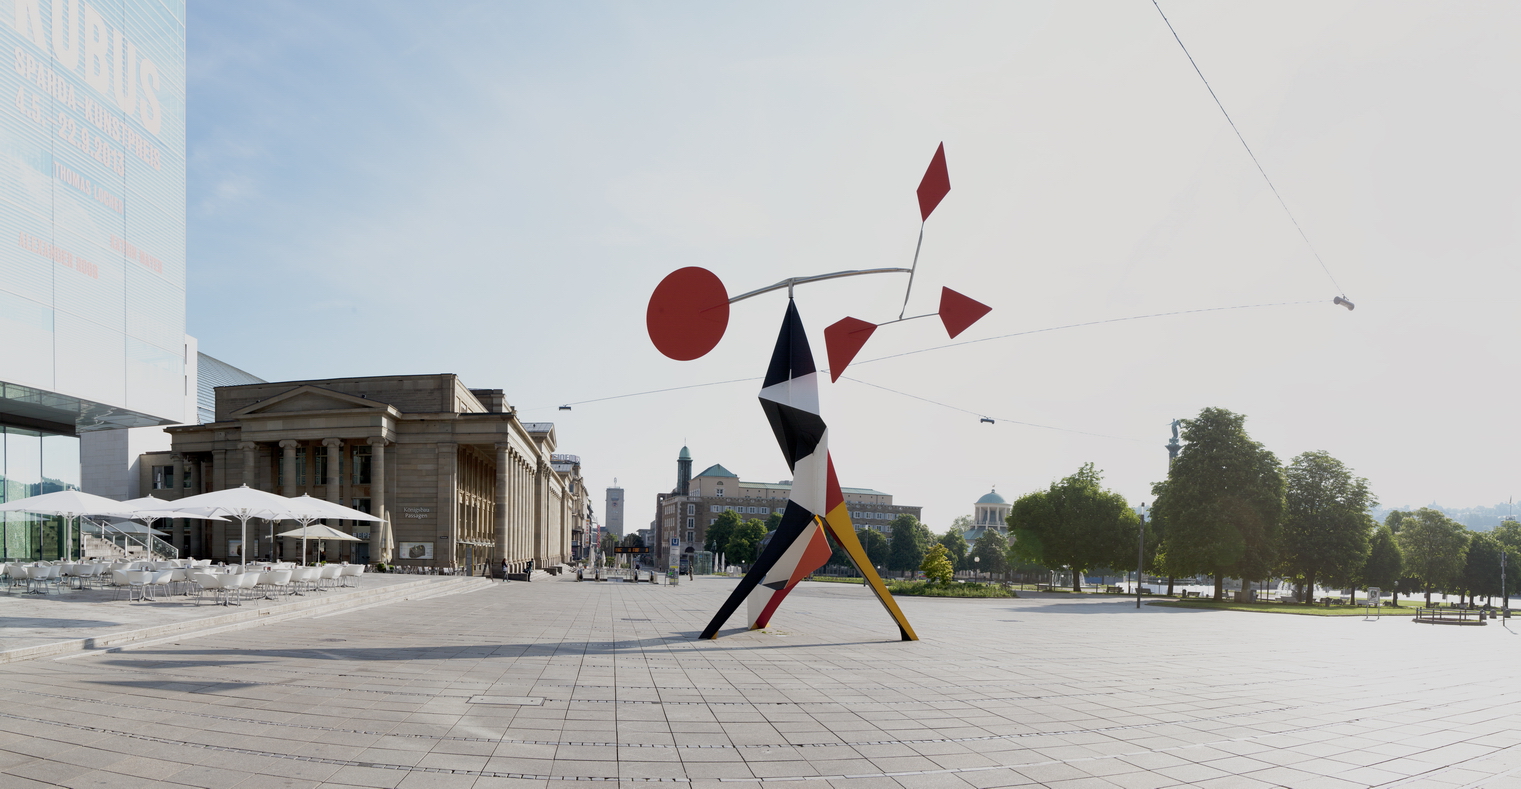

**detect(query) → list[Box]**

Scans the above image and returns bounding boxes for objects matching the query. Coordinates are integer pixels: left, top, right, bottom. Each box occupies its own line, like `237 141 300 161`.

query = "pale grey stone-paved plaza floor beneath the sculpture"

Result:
0 578 1521 789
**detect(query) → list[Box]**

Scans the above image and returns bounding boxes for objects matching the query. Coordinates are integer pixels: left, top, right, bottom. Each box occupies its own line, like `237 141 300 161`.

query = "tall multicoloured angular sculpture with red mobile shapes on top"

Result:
645 144 992 642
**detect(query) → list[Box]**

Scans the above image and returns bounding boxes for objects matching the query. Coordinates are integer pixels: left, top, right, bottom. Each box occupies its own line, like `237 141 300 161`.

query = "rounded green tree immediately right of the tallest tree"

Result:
1278 452 1378 605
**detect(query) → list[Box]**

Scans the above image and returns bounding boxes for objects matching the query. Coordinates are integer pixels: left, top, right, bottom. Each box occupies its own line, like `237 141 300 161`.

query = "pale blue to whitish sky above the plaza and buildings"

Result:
187 0 1521 531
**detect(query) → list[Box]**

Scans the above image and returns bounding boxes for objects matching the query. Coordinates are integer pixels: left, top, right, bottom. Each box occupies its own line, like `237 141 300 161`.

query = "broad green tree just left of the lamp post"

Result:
1008 464 1141 591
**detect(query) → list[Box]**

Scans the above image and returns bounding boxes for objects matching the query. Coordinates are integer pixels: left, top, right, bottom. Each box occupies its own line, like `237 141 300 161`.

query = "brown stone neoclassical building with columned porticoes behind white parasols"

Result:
140 374 589 572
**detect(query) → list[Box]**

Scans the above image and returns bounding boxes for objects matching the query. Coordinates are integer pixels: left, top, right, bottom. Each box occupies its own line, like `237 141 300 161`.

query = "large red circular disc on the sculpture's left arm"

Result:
645 266 729 362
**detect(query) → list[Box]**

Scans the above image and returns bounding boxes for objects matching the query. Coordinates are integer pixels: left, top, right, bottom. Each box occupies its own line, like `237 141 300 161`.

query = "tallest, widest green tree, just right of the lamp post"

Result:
1154 407 1284 600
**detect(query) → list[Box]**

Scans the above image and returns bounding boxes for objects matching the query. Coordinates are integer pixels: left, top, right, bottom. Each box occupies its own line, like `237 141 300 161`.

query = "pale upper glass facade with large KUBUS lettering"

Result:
0 0 195 433
